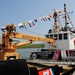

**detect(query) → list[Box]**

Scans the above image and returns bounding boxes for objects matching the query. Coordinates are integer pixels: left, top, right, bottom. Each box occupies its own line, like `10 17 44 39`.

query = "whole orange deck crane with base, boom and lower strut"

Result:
0 24 54 60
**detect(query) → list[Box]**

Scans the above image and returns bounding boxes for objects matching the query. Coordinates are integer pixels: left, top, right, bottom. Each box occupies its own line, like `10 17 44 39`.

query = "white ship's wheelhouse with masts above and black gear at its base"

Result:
30 4 75 61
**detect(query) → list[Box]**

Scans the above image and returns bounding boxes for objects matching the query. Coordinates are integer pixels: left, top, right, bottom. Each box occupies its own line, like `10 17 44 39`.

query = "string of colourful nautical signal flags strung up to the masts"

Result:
0 6 73 32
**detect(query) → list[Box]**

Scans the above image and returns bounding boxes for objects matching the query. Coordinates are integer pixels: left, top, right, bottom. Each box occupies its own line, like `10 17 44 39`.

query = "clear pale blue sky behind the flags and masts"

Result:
0 0 75 36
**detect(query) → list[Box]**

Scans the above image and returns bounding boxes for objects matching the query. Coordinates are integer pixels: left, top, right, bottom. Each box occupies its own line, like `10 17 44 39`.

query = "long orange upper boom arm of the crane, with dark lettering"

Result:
9 32 54 45
